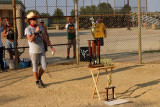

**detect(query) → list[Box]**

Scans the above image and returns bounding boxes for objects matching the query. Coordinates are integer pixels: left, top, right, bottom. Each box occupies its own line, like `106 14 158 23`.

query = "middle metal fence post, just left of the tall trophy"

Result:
74 0 80 63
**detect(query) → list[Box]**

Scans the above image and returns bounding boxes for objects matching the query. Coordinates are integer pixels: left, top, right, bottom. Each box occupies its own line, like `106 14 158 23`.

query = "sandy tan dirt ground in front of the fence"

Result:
0 62 160 107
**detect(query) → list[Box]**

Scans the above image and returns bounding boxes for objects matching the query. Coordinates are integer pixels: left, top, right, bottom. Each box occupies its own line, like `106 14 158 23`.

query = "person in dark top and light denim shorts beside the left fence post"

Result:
3 17 15 60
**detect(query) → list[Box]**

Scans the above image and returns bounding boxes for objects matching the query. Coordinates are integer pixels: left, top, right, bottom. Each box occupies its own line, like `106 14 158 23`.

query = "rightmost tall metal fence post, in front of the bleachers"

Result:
138 0 142 64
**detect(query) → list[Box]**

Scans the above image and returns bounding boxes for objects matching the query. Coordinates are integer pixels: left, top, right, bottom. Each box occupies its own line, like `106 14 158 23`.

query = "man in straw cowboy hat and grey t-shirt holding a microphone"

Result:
25 12 55 88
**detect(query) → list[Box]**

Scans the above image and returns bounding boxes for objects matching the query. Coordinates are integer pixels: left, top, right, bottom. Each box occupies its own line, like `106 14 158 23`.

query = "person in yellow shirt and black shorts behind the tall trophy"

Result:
94 17 106 46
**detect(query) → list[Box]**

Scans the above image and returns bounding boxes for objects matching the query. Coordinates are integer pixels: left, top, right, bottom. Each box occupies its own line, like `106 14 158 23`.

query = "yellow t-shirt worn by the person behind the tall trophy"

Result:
95 23 106 38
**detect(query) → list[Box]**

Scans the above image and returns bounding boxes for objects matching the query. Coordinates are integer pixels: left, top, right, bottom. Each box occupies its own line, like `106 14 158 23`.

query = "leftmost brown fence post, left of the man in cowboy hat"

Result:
12 0 18 69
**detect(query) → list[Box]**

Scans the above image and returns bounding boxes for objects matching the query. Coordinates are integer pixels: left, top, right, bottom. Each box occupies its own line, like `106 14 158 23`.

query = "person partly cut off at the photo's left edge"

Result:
0 17 5 72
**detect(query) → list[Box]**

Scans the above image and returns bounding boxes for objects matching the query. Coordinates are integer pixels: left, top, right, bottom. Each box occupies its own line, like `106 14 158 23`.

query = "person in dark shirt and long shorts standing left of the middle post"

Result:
65 17 76 59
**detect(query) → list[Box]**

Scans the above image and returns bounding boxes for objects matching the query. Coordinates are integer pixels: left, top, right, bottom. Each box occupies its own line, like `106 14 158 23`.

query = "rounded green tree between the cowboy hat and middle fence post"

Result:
53 8 65 23
